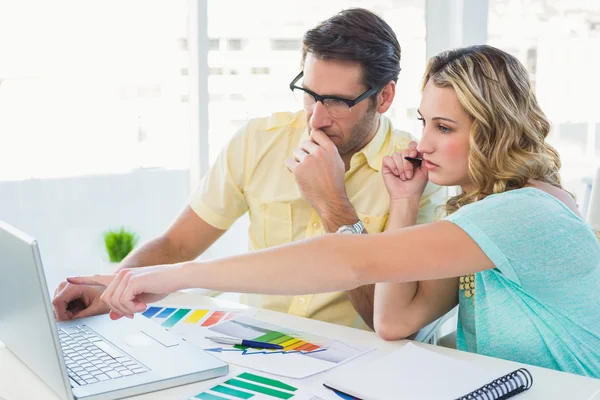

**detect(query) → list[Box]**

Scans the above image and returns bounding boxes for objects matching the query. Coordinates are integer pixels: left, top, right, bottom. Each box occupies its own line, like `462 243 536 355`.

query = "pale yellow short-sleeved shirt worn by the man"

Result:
190 111 446 329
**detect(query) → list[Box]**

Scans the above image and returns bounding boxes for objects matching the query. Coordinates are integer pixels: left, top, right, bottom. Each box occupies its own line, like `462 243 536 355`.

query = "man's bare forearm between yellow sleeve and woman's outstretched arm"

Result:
118 206 225 269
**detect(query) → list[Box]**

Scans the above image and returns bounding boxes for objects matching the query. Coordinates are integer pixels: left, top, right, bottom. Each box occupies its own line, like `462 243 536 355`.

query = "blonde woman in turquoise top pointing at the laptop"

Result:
69 46 600 378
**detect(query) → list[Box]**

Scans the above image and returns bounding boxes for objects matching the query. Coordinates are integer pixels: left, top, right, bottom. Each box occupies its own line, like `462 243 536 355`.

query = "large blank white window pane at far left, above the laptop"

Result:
0 0 189 179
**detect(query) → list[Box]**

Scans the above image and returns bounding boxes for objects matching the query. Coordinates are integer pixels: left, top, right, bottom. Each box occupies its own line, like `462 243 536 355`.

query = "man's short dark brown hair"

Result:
302 8 401 89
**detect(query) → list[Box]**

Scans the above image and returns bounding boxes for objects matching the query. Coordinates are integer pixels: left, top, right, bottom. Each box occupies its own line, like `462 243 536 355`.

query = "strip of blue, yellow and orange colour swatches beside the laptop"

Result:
142 306 240 328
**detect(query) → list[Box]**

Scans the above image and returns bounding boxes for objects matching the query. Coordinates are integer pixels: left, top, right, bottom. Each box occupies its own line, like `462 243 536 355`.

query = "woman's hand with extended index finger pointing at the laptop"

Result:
67 264 185 319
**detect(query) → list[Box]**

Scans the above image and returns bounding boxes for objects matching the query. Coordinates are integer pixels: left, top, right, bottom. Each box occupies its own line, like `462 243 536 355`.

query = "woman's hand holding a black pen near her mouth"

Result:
382 142 427 203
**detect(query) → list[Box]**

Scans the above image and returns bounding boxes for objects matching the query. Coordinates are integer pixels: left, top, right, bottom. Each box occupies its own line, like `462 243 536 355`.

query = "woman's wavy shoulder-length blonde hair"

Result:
422 46 562 214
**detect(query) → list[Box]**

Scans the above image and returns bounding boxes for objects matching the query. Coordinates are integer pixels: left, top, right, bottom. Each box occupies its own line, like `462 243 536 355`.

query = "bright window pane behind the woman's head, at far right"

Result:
488 0 600 205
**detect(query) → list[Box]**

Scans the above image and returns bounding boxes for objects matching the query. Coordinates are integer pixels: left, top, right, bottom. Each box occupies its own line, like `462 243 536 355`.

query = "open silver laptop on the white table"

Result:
0 221 229 400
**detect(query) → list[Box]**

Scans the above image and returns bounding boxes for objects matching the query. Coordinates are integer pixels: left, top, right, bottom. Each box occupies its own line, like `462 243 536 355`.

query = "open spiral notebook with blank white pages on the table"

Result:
324 343 533 400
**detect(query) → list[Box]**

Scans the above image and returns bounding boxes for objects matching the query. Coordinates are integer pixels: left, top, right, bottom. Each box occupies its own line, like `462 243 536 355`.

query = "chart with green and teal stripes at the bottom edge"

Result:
190 372 321 400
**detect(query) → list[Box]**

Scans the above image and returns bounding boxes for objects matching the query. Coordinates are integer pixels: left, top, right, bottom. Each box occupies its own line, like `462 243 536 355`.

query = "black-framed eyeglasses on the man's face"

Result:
290 72 378 118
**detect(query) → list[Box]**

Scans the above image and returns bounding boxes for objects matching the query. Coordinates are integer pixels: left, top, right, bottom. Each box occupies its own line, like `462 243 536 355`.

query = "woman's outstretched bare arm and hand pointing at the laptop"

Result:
68 221 494 316
